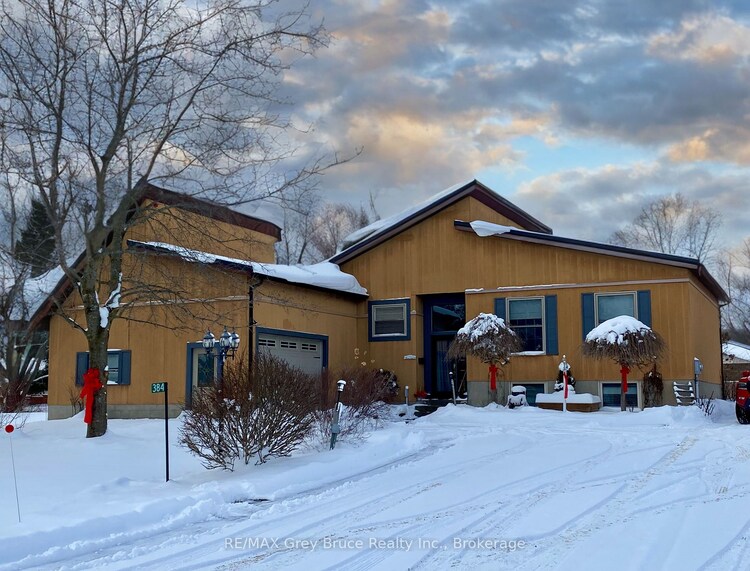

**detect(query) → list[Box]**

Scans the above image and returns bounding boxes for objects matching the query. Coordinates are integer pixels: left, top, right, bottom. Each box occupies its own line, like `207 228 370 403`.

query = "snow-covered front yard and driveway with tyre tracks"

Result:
0 402 750 571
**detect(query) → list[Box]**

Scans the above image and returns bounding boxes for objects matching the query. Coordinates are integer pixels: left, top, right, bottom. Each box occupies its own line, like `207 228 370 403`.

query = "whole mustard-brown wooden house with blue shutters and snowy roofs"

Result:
38 181 726 418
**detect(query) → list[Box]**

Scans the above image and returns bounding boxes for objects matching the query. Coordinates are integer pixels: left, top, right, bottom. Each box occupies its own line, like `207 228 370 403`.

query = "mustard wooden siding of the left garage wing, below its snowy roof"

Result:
49 264 358 412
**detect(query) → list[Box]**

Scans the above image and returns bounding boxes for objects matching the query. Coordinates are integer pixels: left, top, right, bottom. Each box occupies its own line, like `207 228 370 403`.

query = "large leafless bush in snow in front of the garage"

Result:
180 352 320 470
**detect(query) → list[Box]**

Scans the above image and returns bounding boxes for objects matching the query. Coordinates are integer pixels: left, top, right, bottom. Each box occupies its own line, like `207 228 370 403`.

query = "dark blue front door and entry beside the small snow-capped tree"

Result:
423 293 466 398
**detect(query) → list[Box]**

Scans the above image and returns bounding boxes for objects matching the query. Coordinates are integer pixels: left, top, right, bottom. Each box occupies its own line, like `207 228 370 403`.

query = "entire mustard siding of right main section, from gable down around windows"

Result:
341 197 721 396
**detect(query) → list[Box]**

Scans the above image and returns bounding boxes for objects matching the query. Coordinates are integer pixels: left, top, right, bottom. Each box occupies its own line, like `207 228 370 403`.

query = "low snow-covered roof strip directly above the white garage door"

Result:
128 240 367 296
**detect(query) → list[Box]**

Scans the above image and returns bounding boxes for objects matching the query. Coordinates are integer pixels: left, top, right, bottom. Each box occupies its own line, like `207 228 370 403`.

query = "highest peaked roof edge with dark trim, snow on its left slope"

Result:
330 179 552 264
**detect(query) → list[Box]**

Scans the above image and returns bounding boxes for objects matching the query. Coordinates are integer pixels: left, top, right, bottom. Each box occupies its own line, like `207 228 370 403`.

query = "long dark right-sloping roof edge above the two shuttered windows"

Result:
453 220 729 303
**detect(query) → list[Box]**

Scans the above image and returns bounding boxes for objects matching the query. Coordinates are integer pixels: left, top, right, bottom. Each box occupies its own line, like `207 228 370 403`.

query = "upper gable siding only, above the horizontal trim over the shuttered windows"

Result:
341 197 689 300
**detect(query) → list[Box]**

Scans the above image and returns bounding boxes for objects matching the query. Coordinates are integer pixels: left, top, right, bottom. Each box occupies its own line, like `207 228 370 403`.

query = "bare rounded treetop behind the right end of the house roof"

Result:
609 193 721 263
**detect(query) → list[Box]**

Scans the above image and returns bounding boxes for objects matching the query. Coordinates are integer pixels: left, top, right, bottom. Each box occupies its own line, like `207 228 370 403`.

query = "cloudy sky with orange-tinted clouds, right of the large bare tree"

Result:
285 0 750 248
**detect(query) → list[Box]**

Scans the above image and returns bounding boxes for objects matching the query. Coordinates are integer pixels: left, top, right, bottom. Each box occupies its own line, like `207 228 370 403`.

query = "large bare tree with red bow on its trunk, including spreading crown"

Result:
0 0 335 437
